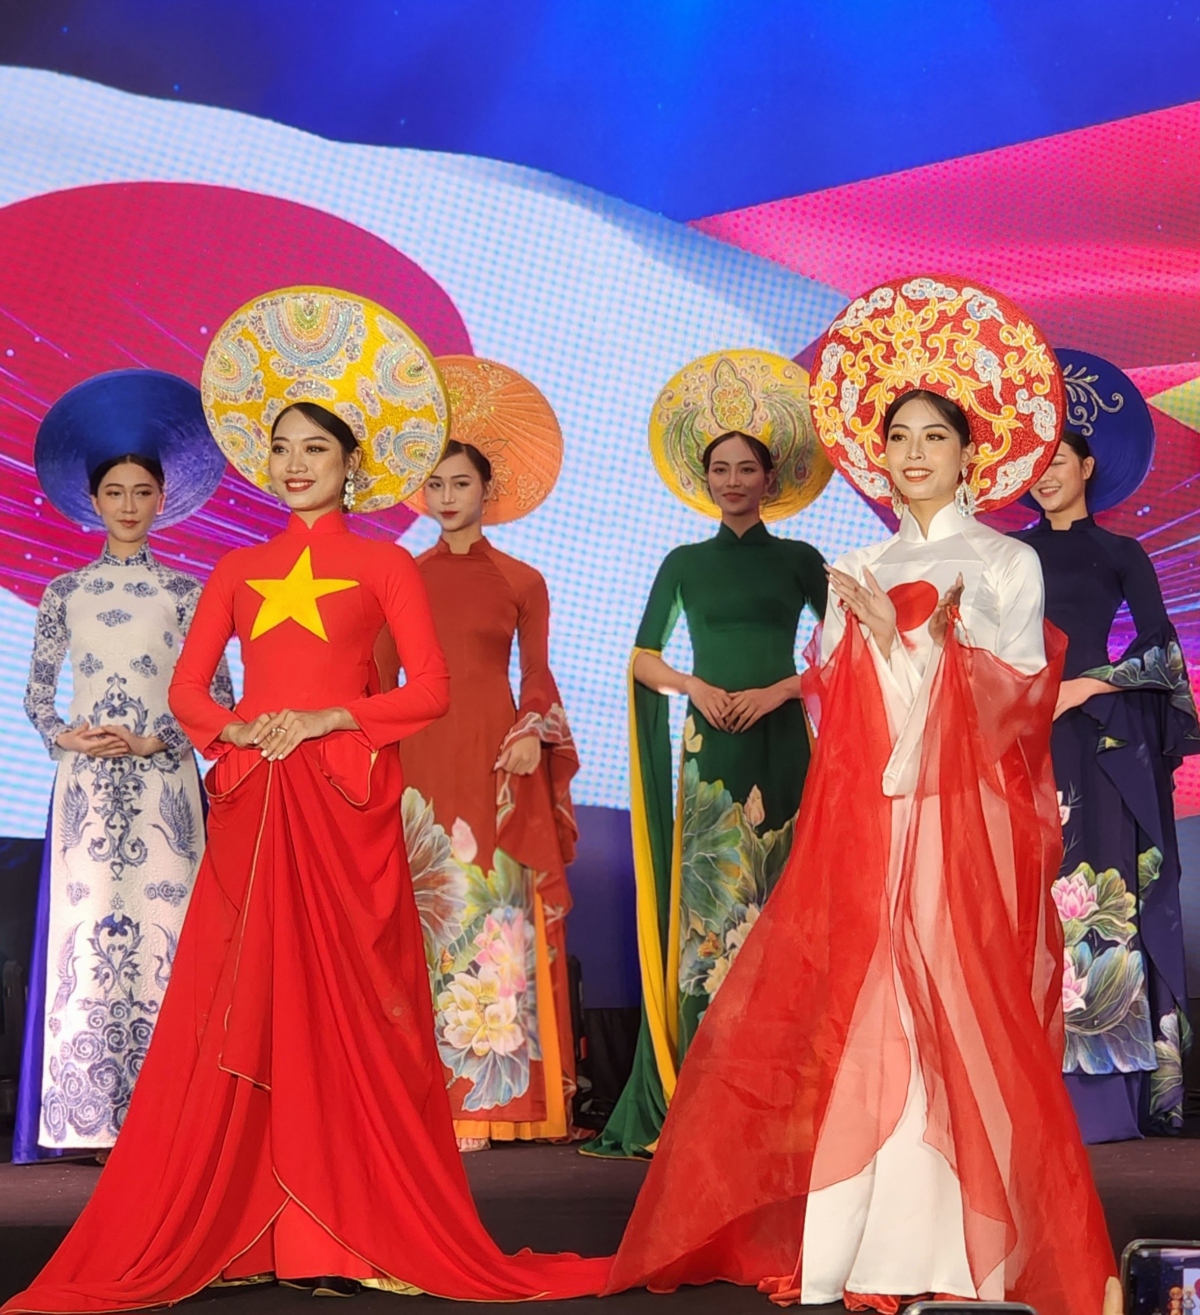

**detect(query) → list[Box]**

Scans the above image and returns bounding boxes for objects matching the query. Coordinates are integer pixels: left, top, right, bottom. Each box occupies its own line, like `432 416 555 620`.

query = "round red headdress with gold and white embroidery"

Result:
808 276 1065 512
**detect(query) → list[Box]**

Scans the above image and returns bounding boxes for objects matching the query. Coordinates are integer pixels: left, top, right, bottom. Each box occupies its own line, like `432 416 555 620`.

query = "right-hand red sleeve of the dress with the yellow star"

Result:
347 548 450 750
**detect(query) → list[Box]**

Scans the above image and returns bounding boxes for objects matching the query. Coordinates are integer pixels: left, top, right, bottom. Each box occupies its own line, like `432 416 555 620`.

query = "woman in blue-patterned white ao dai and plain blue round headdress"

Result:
13 371 233 1162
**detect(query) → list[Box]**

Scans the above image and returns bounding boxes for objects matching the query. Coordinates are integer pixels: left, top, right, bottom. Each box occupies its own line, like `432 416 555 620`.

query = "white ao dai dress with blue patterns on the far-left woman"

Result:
25 543 233 1149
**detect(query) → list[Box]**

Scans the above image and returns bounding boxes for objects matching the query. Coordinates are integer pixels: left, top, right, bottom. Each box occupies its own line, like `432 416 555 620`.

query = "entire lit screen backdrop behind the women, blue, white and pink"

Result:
0 0 1200 836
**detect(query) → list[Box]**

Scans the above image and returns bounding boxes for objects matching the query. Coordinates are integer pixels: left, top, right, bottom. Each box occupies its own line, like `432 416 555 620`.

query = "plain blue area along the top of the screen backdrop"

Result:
7 0 1200 220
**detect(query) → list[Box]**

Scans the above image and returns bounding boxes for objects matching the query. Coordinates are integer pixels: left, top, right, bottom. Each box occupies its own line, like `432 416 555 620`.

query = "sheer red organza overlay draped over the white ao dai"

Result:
610 615 1116 1315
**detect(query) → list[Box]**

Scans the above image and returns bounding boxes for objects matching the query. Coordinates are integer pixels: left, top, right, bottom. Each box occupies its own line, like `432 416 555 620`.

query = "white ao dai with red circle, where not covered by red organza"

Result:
803 494 1046 1303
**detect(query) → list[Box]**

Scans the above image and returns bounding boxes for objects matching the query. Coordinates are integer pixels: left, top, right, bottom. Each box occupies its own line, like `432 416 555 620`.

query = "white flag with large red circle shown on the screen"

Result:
0 70 878 835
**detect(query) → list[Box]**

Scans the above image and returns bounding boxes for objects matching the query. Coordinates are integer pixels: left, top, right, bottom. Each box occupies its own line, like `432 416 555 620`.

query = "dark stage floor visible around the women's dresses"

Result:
0 1137 1200 1315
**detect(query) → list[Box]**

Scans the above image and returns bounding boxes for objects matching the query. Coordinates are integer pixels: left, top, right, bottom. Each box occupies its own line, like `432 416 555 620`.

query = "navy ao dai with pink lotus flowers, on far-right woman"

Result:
1020 517 1200 1141
